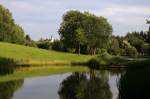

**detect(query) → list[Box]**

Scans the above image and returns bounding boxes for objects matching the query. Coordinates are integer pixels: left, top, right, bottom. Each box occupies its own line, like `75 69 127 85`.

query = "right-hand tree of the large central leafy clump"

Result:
84 12 112 55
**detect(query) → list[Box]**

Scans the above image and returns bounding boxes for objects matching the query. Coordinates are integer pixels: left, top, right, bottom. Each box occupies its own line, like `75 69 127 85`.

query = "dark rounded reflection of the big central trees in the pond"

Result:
58 70 112 99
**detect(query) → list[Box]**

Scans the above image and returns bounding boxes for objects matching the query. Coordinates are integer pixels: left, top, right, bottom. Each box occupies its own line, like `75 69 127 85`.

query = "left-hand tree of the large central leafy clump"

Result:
59 11 84 52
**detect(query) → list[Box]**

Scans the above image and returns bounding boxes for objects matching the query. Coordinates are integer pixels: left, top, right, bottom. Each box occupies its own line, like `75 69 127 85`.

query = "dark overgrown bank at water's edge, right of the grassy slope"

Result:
88 53 150 69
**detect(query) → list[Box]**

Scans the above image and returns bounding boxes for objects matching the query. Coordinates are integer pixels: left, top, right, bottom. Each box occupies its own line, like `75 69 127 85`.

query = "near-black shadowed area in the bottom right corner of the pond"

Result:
118 67 150 99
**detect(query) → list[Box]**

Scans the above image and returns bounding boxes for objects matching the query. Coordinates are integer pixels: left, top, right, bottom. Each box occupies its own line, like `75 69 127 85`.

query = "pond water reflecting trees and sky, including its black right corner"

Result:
0 69 150 99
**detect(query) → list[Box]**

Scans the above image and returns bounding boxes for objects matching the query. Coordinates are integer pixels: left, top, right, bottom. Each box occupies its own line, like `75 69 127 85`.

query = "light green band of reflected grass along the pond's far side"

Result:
0 66 88 82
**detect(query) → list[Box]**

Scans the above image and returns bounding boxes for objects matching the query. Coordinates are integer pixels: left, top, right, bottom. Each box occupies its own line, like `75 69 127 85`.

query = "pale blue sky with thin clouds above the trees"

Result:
0 0 150 40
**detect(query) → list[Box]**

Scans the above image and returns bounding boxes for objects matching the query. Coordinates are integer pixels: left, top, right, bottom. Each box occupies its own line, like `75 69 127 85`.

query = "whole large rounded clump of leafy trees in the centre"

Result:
59 11 112 55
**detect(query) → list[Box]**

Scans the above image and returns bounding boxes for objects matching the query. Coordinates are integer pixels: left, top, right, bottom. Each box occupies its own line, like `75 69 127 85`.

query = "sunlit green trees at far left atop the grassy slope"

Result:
0 5 25 44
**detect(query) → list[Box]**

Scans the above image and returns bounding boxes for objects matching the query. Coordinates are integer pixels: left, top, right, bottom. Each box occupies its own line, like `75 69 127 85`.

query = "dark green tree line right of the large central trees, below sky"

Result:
108 30 150 56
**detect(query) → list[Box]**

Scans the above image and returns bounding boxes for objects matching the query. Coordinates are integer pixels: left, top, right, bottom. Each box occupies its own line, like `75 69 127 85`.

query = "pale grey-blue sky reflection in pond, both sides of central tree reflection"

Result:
13 73 118 99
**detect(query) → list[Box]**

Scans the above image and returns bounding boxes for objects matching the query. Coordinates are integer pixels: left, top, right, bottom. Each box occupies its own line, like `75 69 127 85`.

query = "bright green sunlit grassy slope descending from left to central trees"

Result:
0 42 91 62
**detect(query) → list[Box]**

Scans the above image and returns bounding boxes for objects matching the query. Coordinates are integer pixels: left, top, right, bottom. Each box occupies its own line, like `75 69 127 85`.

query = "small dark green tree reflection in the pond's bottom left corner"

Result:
0 80 24 99
